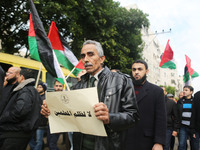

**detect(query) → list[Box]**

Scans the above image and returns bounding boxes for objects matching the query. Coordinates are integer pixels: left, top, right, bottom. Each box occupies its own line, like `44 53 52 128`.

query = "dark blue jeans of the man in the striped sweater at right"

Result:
178 127 199 150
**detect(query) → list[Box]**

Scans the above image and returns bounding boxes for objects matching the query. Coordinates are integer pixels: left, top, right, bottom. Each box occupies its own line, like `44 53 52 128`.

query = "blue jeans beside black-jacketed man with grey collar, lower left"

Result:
29 129 46 150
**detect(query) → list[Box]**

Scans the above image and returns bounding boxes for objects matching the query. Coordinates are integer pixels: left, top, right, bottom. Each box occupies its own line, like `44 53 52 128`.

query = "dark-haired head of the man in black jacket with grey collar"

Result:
17 69 35 83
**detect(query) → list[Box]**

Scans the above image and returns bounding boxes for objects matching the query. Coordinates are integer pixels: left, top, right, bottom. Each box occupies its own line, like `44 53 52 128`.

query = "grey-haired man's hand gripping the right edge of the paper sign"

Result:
94 102 110 124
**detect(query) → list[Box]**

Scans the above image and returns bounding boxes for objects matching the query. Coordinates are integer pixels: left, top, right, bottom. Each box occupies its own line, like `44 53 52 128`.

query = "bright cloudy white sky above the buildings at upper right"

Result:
114 0 200 92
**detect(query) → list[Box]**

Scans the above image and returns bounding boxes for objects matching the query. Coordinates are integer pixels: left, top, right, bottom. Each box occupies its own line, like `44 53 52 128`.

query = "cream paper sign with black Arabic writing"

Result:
46 87 107 136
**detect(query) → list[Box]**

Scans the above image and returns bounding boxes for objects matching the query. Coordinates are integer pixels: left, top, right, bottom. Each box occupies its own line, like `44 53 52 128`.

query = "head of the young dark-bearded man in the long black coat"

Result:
132 60 149 85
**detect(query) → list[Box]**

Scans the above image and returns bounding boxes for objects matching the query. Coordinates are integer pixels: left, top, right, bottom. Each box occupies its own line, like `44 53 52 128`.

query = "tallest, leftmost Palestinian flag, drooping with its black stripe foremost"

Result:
29 0 65 79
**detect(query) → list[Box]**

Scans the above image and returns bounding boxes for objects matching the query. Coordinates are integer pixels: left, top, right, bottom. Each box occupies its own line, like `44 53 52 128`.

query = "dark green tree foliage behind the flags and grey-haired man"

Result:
0 0 149 73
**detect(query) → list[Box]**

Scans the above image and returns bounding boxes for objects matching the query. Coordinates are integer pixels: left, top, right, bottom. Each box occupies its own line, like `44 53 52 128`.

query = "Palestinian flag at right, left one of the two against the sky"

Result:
159 40 176 69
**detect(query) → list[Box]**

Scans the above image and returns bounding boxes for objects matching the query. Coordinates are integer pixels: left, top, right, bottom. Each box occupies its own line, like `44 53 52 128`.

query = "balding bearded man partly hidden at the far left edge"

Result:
0 67 21 115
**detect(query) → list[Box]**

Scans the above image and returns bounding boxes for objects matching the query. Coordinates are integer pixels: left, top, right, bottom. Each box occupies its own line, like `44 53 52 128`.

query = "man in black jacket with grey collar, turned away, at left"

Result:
0 69 41 150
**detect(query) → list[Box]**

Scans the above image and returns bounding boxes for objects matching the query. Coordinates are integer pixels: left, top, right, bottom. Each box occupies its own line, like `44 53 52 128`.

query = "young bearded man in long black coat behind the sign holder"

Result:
126 60 167 150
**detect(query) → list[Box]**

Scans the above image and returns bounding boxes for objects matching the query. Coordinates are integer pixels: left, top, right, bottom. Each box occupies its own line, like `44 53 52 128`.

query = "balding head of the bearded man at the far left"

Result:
5 67 21 84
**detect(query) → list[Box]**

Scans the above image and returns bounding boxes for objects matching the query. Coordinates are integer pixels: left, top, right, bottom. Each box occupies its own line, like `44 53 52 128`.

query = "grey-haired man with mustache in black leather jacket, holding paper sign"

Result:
41 40 138 150
